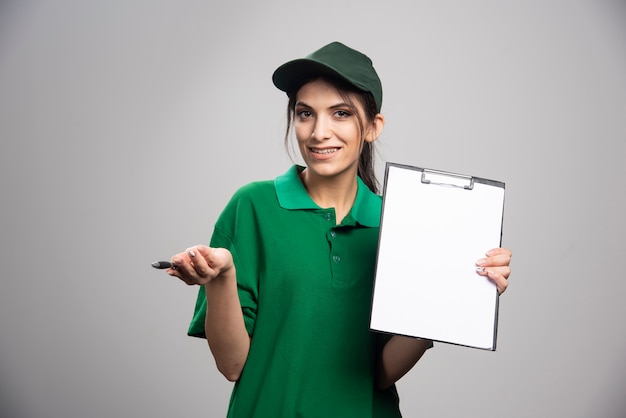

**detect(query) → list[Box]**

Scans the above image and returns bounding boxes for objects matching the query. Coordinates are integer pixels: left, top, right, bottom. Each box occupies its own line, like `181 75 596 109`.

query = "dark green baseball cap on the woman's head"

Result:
272 42 383 112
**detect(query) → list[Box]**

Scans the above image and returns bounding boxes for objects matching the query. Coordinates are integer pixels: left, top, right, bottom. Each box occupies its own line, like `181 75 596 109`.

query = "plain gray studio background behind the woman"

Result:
0 0 626 418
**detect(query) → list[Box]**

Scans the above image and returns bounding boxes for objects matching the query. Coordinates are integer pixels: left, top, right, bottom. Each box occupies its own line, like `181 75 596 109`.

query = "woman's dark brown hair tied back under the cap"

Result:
285 76 379 193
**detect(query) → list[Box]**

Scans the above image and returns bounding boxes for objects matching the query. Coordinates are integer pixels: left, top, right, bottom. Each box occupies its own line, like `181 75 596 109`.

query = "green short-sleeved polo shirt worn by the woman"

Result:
189 166 400 418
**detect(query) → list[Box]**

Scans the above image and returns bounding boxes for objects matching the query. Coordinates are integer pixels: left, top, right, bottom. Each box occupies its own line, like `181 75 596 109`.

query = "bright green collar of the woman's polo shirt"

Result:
274 165 382 227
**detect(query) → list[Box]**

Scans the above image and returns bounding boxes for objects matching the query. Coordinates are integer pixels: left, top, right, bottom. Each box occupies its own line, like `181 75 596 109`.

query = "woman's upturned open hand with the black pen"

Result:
167 245 233 285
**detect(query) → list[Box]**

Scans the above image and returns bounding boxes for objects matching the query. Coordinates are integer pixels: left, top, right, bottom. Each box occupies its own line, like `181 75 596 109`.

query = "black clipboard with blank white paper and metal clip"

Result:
370 163 504 351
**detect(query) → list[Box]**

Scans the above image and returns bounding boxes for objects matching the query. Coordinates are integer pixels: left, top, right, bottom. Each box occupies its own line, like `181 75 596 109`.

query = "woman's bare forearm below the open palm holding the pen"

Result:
204 267 250 382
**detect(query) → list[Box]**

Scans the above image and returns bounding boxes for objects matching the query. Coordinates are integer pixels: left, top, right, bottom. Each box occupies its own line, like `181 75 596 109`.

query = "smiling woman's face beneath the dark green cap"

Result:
294 80 382 183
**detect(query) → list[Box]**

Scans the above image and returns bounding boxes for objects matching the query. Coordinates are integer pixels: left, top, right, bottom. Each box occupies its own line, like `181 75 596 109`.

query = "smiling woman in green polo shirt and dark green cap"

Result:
168 42 511 418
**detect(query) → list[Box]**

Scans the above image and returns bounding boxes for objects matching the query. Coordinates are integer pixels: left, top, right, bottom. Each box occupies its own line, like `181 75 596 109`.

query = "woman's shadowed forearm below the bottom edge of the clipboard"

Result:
376 335 431 389
